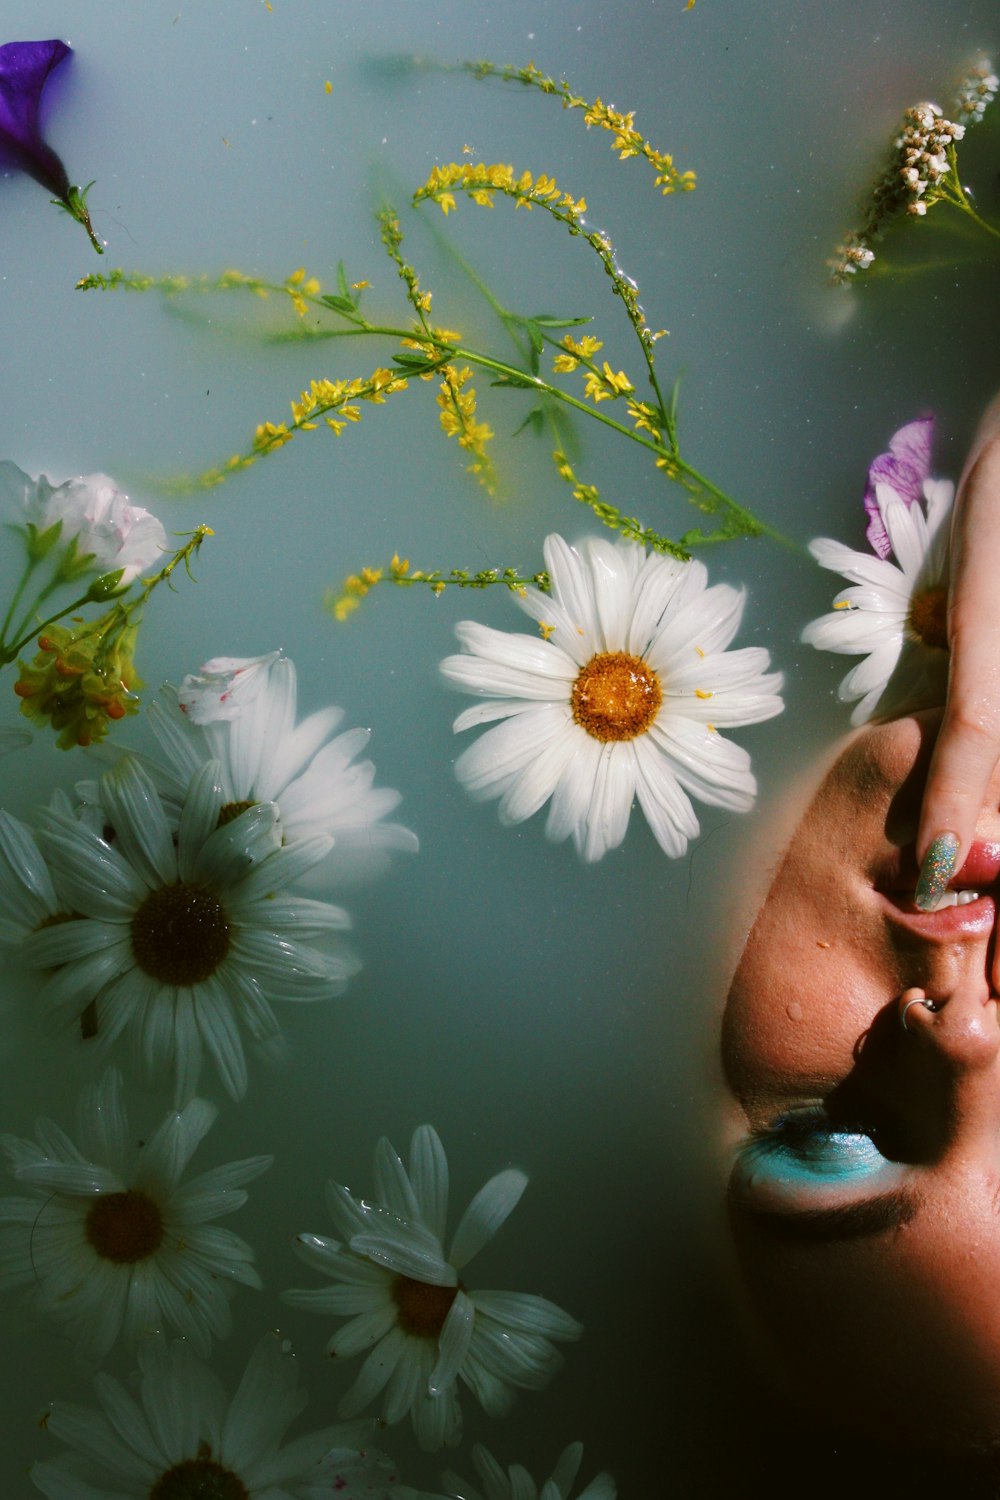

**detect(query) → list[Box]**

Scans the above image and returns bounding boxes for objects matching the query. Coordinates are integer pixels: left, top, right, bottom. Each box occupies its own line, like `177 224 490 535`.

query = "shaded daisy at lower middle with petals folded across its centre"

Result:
283 1125 582 1452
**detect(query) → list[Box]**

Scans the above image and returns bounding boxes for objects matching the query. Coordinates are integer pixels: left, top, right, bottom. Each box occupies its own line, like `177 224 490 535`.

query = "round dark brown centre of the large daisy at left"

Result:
132 881 229 984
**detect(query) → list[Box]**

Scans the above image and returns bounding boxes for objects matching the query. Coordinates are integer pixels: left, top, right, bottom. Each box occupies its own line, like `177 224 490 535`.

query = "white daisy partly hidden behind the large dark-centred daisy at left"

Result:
150 651 417 866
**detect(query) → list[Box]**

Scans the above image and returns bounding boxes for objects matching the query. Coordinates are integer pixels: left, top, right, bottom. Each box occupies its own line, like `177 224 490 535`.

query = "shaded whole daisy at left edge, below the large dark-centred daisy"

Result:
0 1068 273 1361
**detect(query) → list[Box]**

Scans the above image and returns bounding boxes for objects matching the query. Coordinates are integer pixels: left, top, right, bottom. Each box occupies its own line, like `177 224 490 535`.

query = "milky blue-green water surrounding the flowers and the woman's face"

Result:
0 0 1000 1500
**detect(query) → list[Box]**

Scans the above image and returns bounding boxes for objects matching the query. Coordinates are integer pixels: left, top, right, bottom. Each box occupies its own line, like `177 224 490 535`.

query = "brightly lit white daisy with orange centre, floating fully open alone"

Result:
441 536 784 861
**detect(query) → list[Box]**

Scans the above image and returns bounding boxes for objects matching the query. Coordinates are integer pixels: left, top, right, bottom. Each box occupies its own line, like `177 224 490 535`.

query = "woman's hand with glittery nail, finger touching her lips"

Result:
915 396 1000 906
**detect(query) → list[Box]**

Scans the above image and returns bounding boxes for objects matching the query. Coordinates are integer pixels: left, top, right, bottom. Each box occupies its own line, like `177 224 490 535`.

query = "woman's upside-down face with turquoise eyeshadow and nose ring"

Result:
723 714 1000 1443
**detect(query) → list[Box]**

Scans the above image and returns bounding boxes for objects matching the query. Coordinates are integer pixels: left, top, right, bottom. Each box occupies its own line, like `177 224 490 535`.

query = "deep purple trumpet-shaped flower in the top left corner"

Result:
0 41 103 255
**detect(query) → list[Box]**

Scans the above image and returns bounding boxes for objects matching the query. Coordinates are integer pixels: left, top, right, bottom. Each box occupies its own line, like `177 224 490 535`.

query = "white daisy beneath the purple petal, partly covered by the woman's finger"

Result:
802 480 955 725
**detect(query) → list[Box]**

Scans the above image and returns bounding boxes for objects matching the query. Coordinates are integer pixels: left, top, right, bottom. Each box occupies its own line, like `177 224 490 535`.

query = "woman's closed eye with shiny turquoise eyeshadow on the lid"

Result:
738 1109 886 1182
